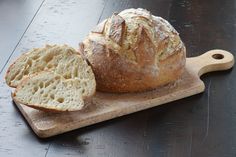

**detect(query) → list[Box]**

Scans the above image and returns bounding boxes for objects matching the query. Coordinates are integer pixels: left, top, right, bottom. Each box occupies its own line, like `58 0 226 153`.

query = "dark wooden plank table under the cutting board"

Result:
0 0 236 157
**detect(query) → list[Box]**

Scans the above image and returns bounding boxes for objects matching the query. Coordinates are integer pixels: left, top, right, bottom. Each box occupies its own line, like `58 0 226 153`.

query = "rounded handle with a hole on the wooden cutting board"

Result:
186 49 234 76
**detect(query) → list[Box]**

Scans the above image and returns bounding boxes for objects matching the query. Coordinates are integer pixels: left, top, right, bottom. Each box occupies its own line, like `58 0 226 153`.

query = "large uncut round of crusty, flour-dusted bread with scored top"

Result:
79 9 186 92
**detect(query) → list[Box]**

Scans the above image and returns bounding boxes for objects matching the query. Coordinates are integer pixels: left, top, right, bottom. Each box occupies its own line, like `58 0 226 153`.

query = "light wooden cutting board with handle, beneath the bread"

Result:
12 50 234 138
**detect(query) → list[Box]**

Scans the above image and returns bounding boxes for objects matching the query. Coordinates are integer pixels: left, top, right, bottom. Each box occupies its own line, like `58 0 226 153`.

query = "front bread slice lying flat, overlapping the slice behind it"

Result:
13 71 95 111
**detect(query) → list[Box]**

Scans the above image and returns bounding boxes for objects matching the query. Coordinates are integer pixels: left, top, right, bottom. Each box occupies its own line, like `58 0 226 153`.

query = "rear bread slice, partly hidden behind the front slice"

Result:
6 45 92 87
